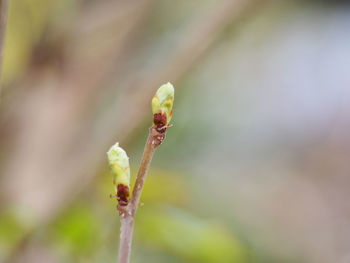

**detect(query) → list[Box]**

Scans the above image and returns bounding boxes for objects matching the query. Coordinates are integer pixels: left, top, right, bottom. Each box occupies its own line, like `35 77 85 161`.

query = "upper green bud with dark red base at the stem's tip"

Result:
152 82 174 132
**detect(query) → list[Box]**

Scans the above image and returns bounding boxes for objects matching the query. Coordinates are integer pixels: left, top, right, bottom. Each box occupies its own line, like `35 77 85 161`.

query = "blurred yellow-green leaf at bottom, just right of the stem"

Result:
136 207 247 263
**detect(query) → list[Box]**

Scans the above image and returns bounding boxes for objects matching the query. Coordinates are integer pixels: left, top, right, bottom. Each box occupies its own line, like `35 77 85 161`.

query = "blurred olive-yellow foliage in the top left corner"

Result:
2 0 75 85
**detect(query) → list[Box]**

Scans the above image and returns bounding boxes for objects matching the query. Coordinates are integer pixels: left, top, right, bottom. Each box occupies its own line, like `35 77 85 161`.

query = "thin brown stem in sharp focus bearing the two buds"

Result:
118 126 166 263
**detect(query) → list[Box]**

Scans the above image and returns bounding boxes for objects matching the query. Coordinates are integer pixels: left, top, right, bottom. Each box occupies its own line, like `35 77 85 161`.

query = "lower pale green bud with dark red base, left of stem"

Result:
107 143 130 206
